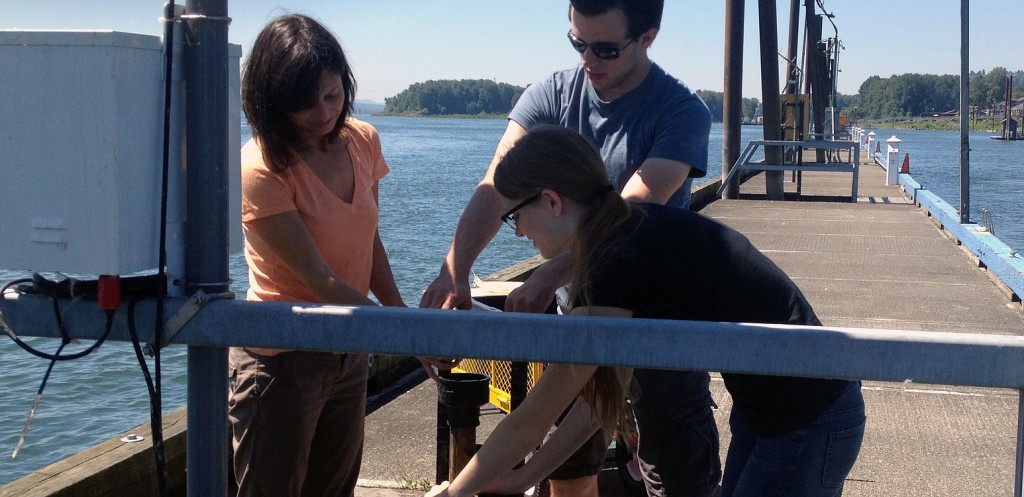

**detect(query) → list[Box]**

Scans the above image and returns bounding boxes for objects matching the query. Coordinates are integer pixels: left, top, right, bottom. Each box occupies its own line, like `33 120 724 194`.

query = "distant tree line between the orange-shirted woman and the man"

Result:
384 79 525 115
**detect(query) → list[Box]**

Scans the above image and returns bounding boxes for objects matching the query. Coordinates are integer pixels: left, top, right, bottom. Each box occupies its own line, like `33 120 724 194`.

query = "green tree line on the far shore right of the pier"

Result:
840 68 1024 119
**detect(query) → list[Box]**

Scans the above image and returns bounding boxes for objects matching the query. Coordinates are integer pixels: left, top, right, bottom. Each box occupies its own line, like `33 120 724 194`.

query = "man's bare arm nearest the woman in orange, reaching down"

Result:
420 120 526 308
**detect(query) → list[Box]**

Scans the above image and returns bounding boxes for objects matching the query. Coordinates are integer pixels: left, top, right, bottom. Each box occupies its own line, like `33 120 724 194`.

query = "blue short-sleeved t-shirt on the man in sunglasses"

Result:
509 64 711 209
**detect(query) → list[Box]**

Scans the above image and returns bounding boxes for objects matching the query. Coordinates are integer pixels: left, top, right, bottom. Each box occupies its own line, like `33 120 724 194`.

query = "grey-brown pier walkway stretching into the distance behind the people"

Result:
356 149 1024 497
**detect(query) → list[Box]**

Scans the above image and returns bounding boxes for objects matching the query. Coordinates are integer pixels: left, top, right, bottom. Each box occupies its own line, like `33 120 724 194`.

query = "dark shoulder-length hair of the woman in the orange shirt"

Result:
242 14 355 172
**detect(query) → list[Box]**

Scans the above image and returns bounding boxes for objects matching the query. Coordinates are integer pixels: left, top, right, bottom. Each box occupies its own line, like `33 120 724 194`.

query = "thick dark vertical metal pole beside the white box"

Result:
184 0 229 496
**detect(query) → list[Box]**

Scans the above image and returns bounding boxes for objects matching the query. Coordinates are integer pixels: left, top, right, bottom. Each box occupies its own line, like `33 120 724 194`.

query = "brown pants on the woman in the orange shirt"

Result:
227 347 367 497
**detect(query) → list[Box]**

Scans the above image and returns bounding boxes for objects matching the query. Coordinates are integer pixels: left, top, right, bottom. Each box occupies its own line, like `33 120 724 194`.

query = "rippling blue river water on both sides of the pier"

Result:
0 116 1024 485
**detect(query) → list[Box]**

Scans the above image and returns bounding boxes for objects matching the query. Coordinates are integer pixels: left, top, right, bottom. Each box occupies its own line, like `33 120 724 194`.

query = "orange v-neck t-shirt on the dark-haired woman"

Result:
242 118 388 302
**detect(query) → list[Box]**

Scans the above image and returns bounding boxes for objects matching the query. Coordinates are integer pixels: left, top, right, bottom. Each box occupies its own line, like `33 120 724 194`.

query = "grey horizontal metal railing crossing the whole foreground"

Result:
0 295 1024 496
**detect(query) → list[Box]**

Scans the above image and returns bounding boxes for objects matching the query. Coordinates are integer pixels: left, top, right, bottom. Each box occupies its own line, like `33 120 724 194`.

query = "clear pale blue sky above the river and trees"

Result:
0 0 1024 101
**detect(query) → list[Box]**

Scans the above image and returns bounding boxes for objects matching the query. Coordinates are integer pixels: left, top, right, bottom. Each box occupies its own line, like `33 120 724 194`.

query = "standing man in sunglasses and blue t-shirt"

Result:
420 0 721 497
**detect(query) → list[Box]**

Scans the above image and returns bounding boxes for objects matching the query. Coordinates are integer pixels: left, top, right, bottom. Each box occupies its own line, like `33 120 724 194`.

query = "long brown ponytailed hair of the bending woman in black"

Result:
495 124 632 434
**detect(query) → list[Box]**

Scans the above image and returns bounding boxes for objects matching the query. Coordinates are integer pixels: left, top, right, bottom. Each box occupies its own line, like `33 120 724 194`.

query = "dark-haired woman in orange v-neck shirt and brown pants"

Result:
228 15 404 496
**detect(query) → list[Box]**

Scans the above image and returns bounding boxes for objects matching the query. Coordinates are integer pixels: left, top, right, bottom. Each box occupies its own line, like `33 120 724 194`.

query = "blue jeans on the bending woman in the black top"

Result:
722 381 865 497
